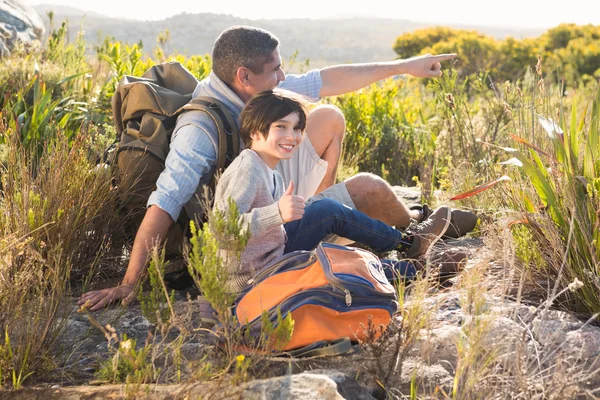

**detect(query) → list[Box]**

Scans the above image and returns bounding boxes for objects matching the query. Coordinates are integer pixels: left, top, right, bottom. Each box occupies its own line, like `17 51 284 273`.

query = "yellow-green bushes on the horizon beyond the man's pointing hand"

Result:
394 24 600 87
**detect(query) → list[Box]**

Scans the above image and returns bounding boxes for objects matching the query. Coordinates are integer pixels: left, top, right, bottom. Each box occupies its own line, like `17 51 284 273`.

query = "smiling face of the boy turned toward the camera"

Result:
250 113 302 168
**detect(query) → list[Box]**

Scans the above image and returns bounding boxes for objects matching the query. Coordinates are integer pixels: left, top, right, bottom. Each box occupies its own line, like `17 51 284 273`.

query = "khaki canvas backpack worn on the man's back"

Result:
112 62 240 230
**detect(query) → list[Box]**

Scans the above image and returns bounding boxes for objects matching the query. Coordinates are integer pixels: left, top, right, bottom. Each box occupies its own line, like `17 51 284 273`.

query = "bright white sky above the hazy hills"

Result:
25 0 600 28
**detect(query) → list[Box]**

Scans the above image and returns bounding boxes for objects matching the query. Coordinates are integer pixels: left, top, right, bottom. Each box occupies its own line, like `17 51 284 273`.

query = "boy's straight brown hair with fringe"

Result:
240 89 308 148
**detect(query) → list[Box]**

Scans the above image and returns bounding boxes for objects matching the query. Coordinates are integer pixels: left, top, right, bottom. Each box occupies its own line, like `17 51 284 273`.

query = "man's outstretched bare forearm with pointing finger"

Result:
319 54 456 97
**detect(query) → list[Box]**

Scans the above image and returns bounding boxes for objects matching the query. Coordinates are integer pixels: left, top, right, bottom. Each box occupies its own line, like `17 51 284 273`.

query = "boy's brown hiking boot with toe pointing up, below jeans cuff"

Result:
404 206 452 258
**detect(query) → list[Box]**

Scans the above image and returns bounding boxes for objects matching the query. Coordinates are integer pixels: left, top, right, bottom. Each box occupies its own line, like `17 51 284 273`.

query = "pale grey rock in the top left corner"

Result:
0 0 45 57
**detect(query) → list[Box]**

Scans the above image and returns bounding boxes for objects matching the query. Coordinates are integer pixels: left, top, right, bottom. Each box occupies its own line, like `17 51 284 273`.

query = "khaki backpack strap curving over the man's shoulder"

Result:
181 96 240 171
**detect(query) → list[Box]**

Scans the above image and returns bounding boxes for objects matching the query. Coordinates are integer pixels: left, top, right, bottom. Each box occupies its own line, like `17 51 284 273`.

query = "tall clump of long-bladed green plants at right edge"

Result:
454 65 600 314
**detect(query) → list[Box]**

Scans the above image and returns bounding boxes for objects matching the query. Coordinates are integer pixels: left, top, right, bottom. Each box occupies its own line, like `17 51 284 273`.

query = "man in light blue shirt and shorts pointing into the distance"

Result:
79 26 472 310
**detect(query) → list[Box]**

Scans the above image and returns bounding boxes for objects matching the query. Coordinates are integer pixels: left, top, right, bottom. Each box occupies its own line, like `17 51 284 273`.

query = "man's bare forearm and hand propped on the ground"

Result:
77 206 173 311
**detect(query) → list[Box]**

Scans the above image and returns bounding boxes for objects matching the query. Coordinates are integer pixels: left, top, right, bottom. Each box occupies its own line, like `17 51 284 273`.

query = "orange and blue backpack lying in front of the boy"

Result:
233 243 398 356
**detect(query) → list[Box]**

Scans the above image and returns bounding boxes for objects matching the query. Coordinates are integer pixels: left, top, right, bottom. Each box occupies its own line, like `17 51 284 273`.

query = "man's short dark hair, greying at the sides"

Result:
212 25 279 84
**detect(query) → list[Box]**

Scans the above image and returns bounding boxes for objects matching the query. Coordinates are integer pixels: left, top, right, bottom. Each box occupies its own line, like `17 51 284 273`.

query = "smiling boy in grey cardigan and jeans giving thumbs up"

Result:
215 90 451 292
